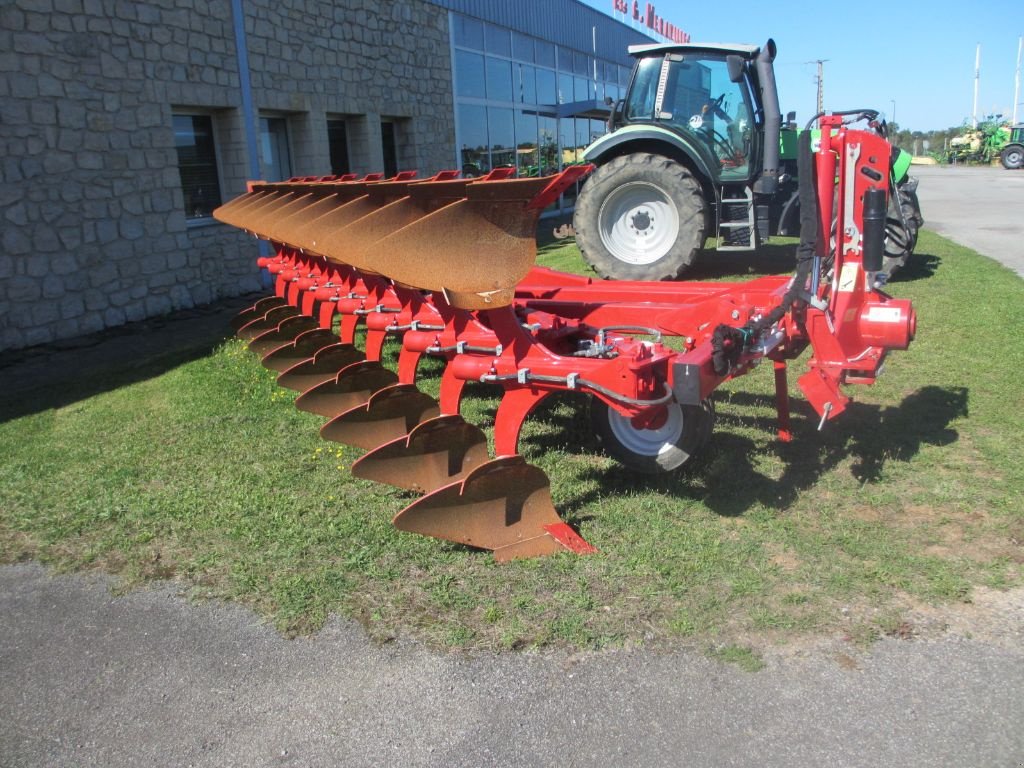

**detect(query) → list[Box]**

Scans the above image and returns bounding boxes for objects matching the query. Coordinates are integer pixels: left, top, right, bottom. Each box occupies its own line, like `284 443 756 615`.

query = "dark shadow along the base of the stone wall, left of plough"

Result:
0 296 259 423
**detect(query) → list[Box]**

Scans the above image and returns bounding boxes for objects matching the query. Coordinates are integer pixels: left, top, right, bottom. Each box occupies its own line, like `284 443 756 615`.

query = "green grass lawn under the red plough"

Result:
0 231 1024 669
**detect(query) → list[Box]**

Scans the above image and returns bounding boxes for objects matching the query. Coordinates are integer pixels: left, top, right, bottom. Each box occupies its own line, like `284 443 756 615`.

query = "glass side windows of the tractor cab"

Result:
626 53 755 180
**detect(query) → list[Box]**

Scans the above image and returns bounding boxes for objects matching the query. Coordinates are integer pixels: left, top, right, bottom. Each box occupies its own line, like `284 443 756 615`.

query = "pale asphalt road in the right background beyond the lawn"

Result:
910 166 1024 276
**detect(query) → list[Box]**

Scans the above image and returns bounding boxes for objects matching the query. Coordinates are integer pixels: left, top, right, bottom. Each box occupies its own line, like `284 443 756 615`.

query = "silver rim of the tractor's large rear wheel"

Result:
597 181 679 264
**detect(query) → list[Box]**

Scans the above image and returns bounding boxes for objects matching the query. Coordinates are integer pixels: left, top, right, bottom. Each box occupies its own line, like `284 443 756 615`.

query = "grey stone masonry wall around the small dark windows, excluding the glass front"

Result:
0 0 455 350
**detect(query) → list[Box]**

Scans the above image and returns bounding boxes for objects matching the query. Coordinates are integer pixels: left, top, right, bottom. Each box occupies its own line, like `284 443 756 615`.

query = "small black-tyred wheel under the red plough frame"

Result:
590 397 715 475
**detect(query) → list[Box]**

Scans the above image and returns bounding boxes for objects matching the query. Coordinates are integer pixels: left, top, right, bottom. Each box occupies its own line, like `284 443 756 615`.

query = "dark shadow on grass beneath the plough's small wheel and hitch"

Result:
524 386 968 519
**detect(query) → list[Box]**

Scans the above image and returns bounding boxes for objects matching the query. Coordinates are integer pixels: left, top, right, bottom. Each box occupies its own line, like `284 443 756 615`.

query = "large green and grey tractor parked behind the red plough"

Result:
572 40 924 280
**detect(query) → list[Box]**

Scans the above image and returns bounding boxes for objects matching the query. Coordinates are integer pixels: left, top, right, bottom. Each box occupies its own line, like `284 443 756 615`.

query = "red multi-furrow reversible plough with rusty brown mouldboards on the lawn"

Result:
214 116 915 560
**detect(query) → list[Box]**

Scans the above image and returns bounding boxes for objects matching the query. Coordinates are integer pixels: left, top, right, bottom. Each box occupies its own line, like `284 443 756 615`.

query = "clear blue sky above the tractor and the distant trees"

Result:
583 0 1024 131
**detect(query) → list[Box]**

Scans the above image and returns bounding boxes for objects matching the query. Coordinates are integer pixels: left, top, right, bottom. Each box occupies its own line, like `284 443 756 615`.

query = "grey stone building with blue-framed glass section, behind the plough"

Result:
0 0 644 350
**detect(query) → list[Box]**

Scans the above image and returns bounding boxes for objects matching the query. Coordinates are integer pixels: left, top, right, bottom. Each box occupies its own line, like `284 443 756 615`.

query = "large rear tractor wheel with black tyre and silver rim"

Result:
572 153 708 281
